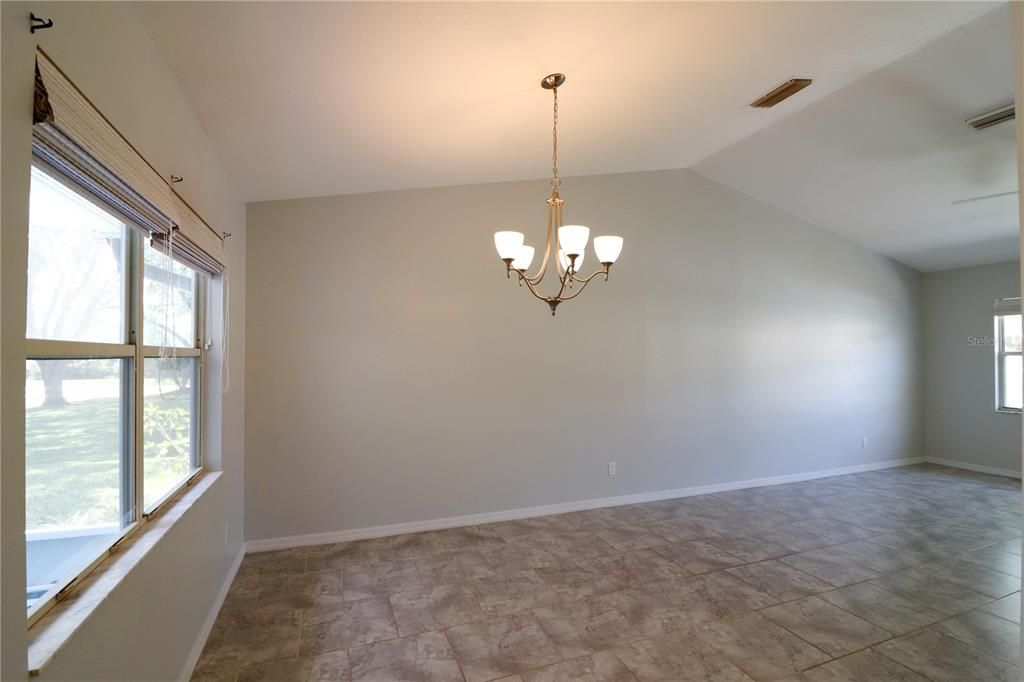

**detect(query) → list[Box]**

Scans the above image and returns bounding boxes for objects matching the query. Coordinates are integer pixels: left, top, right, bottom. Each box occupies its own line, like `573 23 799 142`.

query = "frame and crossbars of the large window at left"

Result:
25 157 209 627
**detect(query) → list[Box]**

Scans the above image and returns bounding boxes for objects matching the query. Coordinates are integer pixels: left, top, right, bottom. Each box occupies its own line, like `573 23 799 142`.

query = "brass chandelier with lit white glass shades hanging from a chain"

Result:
495 74 623 316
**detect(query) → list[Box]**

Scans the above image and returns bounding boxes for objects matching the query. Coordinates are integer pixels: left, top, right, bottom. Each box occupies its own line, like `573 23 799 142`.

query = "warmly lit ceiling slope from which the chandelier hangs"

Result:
135 2 992 201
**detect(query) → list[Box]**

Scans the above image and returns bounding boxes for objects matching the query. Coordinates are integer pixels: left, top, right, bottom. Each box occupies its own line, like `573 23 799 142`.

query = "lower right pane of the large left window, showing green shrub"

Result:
142 357 199 509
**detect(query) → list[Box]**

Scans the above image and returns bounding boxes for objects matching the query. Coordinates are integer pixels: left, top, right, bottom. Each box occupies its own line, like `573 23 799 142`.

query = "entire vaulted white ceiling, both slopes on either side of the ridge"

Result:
136 2 1012 269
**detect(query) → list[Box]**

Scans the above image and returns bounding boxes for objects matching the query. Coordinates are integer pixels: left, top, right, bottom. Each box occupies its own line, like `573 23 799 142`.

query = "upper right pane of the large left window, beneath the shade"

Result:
142 248 196 348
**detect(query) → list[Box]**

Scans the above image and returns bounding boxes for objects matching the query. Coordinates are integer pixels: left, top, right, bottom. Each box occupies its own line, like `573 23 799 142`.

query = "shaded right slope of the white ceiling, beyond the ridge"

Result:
694 6 1019 271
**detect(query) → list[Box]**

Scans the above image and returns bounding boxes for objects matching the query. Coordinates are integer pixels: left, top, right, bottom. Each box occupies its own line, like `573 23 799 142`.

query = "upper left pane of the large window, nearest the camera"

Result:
26 167 127 343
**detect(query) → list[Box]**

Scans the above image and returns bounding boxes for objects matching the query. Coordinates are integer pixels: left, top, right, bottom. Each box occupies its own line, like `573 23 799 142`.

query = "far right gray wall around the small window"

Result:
924 262 1021 472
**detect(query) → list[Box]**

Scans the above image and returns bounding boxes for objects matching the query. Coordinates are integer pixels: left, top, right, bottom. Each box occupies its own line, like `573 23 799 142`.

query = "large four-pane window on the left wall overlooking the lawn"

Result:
25 166 206 616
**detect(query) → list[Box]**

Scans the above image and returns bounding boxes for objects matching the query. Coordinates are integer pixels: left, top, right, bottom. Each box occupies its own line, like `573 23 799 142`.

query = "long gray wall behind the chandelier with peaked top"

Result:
246 170 923 539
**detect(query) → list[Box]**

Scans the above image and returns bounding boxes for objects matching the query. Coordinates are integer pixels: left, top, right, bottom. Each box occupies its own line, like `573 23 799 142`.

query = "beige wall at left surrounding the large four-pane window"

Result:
0 2 246 680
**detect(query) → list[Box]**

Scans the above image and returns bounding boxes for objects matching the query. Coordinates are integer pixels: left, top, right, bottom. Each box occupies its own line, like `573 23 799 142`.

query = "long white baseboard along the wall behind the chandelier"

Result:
246 458 925 552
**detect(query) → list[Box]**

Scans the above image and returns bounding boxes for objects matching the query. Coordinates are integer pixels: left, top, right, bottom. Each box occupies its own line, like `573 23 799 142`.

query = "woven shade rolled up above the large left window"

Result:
33 50 225 274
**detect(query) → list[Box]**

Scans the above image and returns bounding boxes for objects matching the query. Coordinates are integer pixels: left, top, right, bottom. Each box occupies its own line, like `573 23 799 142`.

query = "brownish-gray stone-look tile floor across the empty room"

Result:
193 465 1021 682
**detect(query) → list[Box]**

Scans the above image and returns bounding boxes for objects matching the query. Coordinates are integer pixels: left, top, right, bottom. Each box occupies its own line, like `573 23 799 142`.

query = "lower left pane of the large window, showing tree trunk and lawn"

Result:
25 359 131 607
